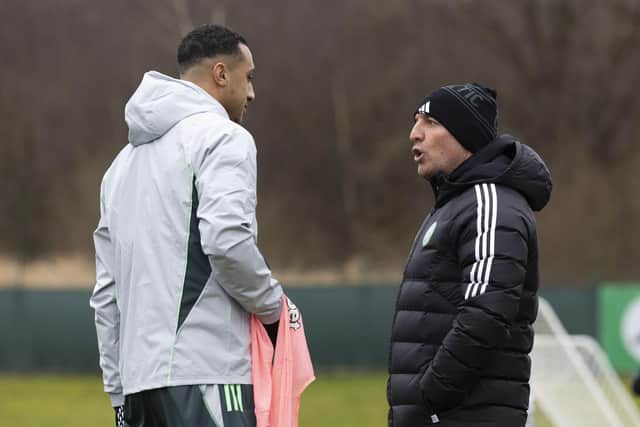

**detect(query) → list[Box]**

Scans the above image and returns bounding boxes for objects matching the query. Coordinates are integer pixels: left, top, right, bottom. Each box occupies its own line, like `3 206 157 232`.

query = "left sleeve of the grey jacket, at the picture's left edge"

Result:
89 181 124 407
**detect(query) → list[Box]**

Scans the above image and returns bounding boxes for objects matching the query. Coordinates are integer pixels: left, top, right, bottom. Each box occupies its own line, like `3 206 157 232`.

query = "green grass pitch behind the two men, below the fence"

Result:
0 374 640 427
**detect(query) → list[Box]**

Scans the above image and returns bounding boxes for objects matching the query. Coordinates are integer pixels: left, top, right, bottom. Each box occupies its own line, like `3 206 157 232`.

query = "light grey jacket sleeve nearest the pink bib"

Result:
193 128 282 324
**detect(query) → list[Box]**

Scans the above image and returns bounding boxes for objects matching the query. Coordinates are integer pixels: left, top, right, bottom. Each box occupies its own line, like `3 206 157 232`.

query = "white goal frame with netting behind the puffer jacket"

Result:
531 298 640 427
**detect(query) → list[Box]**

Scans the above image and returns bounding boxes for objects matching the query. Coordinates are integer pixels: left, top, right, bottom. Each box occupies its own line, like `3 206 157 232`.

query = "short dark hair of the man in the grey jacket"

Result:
178 24 247 73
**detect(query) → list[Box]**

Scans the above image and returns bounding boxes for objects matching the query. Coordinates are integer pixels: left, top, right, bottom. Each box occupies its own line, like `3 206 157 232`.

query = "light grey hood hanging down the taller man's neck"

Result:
124 71 229 146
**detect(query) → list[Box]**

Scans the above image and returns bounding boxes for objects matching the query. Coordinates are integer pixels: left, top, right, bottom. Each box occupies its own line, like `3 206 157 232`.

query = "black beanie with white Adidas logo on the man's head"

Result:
414 83 498 153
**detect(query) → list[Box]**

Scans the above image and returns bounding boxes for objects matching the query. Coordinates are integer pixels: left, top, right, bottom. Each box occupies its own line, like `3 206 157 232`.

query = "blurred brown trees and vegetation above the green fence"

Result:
0 0 640 287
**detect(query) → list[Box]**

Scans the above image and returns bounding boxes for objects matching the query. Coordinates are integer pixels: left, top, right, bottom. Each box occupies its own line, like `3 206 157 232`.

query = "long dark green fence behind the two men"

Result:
0 286 596 371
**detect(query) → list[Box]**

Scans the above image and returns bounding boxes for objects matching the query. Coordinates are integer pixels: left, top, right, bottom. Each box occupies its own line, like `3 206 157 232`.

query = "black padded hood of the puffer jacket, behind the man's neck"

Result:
430 134 553 211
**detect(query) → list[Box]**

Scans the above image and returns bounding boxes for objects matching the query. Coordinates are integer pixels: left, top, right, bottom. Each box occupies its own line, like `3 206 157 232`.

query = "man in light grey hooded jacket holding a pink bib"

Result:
91 25 282 427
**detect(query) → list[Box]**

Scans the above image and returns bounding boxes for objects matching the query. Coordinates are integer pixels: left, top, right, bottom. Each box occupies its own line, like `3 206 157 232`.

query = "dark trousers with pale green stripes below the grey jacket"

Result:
124 384 256 427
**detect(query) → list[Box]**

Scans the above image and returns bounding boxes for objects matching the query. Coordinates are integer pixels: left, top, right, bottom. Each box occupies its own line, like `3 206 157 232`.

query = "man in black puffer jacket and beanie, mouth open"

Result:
387 84 551 427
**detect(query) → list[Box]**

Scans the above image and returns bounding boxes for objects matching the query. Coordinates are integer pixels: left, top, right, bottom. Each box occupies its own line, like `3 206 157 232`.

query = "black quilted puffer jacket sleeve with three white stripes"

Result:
420 184 529 413
